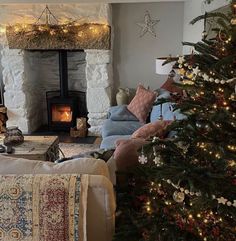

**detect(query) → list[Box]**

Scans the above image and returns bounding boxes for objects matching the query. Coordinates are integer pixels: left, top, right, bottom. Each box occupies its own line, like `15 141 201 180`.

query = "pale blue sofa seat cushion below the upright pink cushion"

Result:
102 119 143 138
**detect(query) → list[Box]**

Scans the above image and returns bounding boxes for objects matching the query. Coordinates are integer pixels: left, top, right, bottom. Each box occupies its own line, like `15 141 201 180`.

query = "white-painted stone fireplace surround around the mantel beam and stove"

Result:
0 3 112 135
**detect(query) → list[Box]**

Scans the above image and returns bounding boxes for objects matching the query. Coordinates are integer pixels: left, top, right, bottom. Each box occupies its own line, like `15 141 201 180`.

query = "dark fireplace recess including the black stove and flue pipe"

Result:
25 49 88 133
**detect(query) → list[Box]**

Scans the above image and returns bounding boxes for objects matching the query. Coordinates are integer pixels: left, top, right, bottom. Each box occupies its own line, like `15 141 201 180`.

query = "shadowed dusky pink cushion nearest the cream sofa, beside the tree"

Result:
113 138 148 171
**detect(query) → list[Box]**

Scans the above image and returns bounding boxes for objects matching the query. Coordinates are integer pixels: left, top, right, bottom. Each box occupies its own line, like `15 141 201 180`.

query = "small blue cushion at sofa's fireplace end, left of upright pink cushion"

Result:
108 105 138 121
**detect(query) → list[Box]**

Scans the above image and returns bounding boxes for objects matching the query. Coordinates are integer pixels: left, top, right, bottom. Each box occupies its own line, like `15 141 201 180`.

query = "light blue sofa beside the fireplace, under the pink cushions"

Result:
100 89 184 149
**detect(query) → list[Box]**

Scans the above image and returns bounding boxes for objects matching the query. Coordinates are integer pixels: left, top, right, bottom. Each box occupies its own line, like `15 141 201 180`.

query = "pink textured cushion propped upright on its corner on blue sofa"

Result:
127 85 156 123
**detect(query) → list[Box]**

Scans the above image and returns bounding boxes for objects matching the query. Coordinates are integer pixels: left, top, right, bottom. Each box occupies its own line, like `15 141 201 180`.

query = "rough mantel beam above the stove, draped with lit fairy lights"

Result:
4 6 111 49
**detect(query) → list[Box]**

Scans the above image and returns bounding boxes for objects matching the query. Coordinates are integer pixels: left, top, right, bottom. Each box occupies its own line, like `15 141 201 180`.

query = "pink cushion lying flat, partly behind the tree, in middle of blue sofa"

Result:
132 120 172 139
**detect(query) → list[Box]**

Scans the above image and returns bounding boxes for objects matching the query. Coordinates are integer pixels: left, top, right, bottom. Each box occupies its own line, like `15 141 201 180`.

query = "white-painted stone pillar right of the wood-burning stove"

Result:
85 50 112 135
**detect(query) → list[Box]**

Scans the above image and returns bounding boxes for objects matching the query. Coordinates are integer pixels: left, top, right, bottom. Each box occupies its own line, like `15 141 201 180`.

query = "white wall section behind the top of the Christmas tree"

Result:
183 0 229 54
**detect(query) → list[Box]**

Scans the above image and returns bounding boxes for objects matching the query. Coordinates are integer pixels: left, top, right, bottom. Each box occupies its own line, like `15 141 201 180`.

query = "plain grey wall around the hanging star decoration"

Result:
112 2 184 89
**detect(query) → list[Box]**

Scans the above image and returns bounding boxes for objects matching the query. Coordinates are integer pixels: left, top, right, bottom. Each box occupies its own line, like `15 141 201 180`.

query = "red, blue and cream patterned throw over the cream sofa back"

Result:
0 174 87 241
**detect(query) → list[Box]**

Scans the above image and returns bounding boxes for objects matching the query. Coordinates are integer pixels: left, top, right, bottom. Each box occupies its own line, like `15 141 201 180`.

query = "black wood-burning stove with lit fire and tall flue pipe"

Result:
46 50 87 131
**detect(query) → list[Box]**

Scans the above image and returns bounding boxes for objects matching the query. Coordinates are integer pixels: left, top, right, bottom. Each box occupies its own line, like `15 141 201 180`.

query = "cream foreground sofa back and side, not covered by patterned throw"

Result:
0 156 116 241
